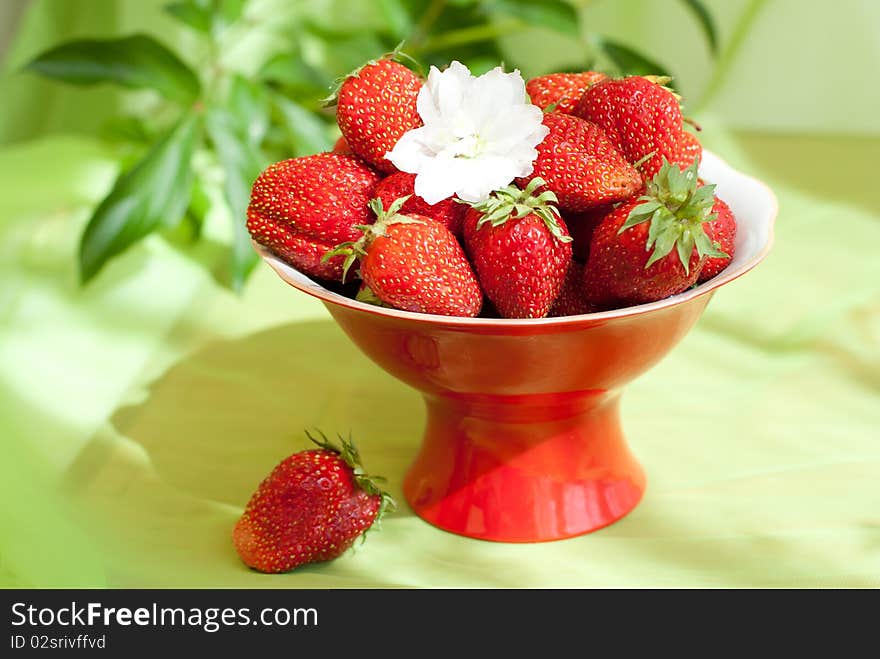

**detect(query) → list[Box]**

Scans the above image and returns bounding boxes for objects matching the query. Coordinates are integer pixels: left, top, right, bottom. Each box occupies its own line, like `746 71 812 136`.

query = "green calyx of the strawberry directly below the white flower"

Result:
464 176 572 243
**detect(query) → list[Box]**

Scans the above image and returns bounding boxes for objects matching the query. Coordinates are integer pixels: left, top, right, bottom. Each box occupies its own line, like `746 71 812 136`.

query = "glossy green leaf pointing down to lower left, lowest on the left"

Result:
79 116 198 283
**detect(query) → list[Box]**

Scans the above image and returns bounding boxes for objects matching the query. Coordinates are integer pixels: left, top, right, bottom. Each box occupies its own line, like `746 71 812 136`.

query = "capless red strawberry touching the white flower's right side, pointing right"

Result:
517 113 642 212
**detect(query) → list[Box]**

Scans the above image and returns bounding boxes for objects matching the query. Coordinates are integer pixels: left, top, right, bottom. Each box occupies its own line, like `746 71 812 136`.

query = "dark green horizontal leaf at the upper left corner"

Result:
25 34 200 103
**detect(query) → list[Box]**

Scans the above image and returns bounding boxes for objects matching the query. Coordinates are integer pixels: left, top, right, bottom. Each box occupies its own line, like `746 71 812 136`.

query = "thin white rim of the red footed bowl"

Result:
251 149 779 329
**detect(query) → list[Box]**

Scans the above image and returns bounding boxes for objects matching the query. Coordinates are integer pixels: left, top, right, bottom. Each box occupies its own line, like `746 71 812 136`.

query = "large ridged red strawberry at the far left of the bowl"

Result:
247 153 379 280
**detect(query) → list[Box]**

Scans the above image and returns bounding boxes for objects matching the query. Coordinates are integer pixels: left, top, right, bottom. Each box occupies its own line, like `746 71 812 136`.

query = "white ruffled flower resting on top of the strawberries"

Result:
385 62 549 204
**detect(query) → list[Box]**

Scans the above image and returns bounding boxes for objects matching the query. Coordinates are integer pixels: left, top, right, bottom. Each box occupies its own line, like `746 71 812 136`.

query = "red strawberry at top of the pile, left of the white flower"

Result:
331 59 422 174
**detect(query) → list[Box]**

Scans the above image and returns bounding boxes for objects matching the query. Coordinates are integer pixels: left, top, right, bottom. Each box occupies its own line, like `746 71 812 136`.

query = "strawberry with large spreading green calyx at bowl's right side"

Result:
584 161 725 307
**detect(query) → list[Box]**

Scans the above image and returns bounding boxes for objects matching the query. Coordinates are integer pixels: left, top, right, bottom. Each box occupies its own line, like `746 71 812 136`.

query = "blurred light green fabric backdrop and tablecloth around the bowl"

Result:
0 0 880 587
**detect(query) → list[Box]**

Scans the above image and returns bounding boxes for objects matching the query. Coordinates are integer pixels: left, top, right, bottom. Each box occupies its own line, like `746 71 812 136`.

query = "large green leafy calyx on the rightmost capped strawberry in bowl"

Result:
618 158 728 273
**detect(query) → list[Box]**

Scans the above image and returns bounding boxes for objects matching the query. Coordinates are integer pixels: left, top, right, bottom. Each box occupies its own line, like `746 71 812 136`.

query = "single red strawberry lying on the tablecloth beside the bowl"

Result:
232 433 393 573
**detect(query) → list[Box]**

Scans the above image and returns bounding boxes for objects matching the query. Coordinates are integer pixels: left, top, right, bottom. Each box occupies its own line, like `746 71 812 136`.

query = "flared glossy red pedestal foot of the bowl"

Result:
404 391 645 542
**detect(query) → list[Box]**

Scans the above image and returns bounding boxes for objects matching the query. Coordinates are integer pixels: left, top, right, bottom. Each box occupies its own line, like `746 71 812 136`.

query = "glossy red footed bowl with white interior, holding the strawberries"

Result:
255 152 777 542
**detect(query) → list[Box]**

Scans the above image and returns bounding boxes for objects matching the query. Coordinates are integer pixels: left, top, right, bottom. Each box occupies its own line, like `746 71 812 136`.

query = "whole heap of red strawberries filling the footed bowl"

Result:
247 58 736 318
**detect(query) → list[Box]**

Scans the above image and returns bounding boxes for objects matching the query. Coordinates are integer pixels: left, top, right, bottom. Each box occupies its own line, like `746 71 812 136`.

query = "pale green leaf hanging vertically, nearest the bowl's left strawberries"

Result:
206 108 265 291
